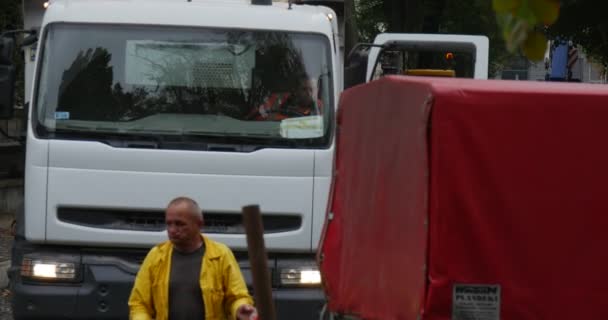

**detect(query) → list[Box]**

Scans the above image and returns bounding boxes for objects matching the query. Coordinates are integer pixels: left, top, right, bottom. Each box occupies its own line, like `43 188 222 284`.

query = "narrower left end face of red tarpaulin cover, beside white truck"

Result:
321 80 431 319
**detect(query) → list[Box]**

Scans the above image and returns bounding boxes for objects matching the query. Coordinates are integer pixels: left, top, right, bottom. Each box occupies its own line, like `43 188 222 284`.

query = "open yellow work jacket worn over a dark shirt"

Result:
129 235 253 320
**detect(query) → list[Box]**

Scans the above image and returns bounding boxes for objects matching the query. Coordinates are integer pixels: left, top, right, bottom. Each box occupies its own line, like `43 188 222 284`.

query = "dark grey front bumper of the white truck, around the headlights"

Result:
9 246 325 320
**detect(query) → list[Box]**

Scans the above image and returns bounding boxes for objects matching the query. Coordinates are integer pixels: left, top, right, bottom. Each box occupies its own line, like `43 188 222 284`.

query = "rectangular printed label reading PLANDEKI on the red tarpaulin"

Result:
452 284 500 320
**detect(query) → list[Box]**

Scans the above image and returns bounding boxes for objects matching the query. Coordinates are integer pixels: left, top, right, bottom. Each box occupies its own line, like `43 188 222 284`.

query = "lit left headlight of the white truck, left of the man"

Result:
21 258 77 281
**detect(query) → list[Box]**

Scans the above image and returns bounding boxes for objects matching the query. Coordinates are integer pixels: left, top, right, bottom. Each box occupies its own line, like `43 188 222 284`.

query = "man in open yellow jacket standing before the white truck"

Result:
129 197 257 320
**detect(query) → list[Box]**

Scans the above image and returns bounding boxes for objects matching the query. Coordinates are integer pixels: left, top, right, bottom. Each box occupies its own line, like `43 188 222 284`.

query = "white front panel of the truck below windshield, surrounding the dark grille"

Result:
41 141 328 251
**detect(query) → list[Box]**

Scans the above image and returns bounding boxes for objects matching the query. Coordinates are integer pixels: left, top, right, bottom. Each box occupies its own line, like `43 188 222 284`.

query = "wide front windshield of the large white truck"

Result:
34 23 333 147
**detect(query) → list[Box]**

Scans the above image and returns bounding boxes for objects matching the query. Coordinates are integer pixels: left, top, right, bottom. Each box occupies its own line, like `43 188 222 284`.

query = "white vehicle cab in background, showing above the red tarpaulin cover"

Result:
345 33 489 88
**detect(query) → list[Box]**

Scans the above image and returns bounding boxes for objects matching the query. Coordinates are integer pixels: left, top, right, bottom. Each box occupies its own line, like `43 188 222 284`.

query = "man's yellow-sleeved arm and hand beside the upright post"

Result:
224 248 255 319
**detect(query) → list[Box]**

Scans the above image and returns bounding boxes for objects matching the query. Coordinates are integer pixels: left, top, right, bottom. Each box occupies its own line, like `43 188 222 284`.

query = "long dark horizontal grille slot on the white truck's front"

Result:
57 207 302 234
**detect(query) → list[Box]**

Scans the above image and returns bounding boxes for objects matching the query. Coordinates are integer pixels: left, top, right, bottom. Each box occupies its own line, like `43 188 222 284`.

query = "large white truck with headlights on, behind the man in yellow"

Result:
0 0 487 319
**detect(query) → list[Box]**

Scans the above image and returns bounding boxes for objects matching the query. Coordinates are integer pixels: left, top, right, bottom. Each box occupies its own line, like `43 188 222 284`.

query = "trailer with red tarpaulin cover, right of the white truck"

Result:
318 77 608 320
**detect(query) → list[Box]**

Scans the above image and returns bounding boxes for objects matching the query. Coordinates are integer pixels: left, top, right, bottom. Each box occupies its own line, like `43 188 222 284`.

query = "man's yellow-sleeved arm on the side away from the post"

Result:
129 248 155 320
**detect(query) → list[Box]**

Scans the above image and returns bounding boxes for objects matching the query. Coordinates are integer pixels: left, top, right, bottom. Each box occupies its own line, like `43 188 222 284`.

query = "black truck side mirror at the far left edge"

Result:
0 37 15 119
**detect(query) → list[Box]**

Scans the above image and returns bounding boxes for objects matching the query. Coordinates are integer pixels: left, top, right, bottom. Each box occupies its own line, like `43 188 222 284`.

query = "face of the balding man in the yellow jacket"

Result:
165 203 203 247
